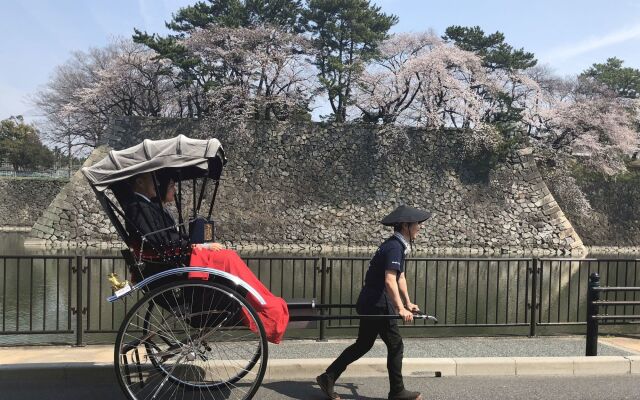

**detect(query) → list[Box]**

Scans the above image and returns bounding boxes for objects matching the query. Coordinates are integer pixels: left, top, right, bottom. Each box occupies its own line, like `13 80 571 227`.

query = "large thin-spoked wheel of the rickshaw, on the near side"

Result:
114 280 268 400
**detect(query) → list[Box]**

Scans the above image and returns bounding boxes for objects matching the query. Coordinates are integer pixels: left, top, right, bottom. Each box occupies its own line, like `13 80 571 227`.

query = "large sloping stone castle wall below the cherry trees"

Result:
26 119 583 254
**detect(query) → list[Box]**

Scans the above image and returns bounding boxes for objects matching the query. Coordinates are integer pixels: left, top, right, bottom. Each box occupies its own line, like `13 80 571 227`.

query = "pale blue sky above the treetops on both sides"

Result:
0 0 640 121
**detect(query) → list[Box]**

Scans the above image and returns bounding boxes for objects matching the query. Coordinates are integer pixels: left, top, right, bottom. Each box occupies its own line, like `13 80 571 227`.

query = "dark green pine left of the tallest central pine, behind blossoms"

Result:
133 0 302 117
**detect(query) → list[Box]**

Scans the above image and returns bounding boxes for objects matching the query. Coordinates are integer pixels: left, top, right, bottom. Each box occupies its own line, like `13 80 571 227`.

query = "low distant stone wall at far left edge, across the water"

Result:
0 178 67 230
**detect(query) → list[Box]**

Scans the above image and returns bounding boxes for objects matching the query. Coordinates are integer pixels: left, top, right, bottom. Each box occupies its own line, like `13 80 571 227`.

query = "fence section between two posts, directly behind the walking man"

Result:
326 258 534 333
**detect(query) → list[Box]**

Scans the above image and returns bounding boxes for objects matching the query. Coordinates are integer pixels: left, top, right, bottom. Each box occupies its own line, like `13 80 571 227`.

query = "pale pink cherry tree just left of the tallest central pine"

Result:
182 25 318 121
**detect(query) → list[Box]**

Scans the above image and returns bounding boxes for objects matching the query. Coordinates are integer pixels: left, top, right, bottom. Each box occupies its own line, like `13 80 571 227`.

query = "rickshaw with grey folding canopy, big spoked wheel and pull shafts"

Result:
82 135 437 400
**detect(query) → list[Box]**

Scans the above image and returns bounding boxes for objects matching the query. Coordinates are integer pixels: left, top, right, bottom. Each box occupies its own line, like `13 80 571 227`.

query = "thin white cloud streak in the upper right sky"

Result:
540 24 640 63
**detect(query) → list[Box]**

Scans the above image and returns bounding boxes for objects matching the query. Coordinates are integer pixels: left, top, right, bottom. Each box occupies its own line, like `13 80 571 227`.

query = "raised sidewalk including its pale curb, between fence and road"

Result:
0 336 640 379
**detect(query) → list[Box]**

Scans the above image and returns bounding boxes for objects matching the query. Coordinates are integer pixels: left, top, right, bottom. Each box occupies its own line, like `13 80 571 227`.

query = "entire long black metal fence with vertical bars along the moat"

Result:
0 256 640 344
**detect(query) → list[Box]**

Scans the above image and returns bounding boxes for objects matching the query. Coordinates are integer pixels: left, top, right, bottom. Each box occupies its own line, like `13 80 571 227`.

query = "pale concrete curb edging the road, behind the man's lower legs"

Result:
0 356 640 384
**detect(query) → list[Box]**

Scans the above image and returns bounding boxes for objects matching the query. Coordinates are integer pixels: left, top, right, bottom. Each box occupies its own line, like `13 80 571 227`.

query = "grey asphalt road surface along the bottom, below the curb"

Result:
0 375 640 400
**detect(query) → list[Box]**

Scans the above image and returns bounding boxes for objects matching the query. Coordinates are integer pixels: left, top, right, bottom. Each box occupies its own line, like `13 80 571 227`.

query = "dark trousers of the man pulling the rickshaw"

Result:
327 319 404 393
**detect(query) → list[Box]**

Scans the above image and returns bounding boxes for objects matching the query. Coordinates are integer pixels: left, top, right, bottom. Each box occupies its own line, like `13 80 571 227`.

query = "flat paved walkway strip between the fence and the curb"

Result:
0 336 640 365
